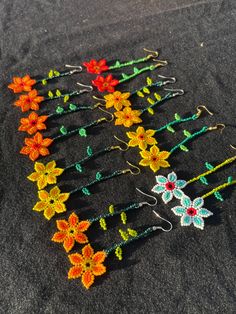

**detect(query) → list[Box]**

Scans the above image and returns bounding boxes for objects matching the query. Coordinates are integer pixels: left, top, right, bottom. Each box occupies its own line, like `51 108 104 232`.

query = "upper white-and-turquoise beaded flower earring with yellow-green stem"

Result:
152 156 236 204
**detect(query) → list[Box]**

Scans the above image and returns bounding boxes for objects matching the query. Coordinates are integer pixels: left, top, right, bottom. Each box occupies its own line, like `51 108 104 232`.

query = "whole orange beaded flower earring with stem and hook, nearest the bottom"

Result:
65 195 173 289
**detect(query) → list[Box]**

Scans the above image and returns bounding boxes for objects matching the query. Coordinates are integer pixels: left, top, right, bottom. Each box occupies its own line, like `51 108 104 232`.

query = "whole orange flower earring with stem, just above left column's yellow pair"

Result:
20 108 114 161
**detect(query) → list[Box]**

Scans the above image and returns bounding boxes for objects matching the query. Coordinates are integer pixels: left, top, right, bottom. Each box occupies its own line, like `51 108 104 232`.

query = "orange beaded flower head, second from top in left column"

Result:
15 89 44 112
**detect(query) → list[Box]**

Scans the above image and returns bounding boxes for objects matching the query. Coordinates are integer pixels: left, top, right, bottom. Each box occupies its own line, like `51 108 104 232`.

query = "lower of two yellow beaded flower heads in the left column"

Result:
33 186 70 220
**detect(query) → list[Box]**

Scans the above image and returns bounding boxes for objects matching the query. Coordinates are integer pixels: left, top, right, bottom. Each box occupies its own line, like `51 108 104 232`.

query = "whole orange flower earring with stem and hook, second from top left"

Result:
14 83 93 112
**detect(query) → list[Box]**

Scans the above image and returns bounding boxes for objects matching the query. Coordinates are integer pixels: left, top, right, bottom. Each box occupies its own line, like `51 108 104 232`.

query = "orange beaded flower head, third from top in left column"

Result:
18 112 48 135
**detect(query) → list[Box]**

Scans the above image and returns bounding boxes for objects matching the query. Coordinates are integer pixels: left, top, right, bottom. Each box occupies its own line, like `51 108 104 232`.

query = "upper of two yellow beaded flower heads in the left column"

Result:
27 160 64 190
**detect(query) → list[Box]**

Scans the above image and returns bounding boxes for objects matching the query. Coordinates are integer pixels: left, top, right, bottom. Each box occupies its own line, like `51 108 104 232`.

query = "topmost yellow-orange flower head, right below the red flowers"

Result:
104 91 131 111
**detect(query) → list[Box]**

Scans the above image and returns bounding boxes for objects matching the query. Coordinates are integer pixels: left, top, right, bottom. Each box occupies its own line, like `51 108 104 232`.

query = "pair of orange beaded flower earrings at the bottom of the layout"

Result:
52 189 172 289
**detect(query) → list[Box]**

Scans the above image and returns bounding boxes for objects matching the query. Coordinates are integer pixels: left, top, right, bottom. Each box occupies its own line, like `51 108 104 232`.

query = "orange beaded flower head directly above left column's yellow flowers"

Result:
20 132 53 161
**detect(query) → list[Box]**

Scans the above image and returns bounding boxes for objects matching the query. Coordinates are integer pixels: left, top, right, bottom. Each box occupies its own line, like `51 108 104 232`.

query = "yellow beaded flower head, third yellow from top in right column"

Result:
126 126 157 150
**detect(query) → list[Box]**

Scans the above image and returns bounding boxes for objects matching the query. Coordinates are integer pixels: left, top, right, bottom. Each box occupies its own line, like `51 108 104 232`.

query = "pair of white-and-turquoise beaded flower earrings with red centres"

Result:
152 156 236 230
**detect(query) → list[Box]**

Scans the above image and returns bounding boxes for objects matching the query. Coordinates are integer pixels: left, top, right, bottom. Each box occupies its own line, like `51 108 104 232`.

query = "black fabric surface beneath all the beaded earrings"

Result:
0 0 236 314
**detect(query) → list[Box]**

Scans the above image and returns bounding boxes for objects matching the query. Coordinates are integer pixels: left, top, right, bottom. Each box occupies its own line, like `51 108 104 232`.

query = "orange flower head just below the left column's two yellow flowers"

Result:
52 213 90 253
